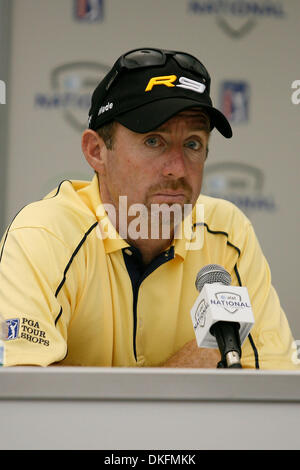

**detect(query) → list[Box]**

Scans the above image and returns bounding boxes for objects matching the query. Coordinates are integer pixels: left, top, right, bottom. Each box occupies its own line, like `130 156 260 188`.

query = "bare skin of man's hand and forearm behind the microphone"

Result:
161 339 221 369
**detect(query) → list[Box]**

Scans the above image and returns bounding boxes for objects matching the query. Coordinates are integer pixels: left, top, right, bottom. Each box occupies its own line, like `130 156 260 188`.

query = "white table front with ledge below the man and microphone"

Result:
0 367 300 450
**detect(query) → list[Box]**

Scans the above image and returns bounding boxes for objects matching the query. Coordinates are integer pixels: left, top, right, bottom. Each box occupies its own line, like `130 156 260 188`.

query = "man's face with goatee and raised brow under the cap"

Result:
99 110 209 218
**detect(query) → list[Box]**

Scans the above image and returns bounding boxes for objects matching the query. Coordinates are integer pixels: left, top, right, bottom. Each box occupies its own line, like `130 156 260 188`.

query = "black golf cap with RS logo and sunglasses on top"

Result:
89 48 232 138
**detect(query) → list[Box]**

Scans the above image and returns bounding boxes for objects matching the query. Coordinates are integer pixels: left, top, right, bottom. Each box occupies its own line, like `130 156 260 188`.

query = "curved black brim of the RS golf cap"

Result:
114 97 232 139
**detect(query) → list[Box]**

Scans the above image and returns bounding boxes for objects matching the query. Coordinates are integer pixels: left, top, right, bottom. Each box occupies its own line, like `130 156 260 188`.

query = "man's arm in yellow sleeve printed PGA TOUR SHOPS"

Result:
0 227 68 366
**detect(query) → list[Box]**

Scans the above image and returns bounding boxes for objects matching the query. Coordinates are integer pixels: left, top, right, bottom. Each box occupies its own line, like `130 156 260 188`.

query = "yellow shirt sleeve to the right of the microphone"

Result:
237 224 299 370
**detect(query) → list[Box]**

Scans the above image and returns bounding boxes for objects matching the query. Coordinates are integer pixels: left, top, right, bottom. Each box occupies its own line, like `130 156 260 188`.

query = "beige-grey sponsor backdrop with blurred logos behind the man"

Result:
0 0 300 339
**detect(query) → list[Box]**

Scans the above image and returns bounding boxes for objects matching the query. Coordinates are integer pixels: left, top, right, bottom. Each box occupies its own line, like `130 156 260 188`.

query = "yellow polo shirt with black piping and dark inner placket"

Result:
0 176 298 369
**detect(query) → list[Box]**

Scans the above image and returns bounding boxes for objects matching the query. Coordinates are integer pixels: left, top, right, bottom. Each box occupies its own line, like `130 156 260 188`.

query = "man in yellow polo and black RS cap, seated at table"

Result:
0 49 295 369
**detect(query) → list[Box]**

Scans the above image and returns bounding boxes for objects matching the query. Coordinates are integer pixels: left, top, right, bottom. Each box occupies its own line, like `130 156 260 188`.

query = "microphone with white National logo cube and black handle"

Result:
190 264 254 369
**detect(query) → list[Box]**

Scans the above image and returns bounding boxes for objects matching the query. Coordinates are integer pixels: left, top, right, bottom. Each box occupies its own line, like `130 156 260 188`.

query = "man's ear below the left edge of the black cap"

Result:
81 129 107 175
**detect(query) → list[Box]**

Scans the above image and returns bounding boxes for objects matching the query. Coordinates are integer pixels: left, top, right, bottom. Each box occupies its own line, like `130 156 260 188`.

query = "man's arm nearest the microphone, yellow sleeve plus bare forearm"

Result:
159 219 300 370
